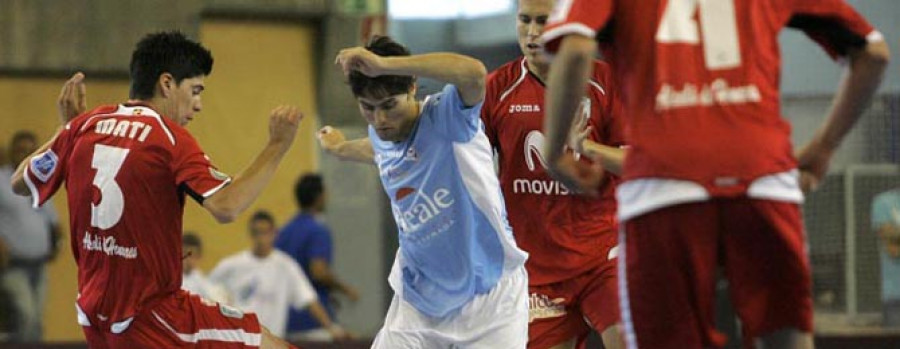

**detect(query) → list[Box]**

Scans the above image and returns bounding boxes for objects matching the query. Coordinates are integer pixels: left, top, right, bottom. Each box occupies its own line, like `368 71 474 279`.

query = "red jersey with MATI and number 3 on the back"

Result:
25 105 231 332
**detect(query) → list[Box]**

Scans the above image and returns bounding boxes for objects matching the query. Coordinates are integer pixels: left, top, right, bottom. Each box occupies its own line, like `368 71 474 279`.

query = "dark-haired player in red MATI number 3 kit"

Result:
12 32 303 349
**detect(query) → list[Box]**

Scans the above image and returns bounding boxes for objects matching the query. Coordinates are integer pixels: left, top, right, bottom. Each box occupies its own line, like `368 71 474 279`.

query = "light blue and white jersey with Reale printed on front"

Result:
369 85 528 317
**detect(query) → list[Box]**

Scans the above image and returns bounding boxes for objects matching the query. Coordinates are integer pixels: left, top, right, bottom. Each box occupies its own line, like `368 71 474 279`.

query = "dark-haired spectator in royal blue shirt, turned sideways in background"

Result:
275 173 359 341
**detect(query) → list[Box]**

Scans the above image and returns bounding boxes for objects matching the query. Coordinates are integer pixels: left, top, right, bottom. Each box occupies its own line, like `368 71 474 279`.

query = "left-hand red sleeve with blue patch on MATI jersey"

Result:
24 122 78 208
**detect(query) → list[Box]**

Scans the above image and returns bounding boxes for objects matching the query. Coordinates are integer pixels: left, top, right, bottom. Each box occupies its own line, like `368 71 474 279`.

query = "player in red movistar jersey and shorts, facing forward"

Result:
481 0 625 349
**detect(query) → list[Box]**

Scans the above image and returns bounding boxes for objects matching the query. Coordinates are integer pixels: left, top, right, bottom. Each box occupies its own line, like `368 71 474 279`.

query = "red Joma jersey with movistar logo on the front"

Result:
481 57 624 285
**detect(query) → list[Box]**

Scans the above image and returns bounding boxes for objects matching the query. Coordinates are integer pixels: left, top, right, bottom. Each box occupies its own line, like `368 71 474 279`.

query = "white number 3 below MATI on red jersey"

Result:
91 144 130 229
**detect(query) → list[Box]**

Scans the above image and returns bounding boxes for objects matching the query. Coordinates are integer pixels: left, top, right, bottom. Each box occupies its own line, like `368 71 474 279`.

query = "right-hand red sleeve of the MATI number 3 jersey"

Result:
173 132 231 204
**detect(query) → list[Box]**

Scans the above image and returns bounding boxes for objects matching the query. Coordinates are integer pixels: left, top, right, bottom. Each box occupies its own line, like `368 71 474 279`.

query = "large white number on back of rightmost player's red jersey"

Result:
656 0 741 70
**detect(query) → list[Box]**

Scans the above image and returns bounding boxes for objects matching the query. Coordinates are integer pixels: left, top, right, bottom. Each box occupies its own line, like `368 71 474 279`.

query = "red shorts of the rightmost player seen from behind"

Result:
619 198 812 349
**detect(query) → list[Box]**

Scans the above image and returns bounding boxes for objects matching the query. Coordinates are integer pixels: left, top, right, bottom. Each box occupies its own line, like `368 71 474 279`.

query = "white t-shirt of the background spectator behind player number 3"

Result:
209 250 317 337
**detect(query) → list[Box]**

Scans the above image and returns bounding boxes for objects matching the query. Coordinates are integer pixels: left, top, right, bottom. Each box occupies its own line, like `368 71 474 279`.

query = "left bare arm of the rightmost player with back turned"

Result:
544 35 602 193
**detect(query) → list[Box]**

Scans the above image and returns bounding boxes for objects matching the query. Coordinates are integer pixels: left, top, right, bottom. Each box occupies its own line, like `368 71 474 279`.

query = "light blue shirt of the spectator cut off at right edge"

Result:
872 189 900 302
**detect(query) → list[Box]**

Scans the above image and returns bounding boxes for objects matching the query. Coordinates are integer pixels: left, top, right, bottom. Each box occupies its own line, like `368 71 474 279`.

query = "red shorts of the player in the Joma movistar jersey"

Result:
528 246 619 349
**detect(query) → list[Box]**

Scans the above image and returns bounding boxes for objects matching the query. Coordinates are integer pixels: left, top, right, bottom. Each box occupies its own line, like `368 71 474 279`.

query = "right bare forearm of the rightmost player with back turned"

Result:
814 41 890 150
